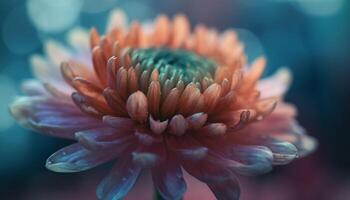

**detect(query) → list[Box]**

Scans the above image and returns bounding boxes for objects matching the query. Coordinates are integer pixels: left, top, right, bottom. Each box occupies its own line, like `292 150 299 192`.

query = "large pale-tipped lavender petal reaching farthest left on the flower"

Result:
10 96 104 139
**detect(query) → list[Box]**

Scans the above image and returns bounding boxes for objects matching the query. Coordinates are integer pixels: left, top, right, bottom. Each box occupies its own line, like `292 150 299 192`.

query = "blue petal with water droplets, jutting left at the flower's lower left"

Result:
46 143 115 173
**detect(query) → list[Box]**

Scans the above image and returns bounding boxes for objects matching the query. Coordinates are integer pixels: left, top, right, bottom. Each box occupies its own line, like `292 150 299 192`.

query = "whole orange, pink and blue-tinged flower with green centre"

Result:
11 11 316 200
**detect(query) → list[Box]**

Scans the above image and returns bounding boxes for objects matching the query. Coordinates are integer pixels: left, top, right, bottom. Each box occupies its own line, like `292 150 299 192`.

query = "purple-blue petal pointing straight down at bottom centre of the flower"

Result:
152 161 186 200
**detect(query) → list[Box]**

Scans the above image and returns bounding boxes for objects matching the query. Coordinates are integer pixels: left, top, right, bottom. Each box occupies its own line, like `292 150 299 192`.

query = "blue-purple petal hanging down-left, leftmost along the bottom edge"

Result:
96 158 142 200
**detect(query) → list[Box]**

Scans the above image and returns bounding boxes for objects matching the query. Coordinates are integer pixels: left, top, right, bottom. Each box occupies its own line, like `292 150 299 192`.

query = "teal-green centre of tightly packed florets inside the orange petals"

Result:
132 48 216 84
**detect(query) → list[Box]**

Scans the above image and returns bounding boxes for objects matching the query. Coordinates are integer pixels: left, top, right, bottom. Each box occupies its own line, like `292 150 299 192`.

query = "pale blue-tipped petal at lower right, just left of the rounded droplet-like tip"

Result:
227 145 273 175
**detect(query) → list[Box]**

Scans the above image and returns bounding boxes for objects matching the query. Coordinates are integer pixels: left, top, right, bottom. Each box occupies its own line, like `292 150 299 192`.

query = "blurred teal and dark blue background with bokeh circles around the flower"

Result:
0 0 350 200
